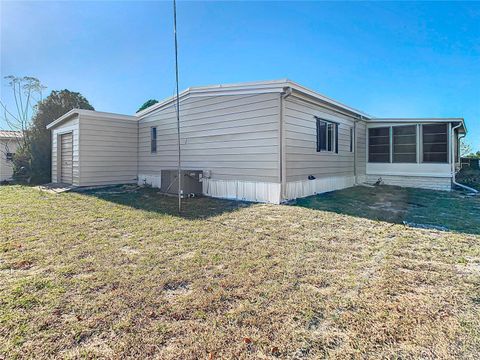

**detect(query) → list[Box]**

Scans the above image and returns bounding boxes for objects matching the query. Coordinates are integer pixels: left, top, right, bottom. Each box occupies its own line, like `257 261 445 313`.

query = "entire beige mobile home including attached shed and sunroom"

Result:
48 80 466 203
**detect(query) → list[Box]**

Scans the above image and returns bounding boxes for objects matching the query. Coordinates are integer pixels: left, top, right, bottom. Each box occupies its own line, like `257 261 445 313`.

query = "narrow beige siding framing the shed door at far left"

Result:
52 116 80 186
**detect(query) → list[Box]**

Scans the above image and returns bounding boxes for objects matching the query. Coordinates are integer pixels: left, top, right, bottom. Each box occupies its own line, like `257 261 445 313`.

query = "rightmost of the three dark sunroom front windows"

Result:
422 124 448 163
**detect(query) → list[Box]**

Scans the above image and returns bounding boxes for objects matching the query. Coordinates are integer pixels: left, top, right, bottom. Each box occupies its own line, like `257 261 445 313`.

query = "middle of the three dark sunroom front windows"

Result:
392 125 417 163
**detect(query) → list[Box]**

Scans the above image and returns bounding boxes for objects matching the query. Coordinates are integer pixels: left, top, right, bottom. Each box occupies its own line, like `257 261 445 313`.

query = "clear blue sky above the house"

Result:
0 1 480 150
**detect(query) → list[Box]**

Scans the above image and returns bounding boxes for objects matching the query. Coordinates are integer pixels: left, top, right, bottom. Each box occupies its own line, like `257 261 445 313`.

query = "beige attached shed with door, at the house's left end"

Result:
47 109 138 186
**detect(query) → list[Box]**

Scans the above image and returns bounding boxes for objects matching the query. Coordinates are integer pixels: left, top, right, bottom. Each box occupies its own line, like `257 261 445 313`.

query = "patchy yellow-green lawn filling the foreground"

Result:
0 186 480 359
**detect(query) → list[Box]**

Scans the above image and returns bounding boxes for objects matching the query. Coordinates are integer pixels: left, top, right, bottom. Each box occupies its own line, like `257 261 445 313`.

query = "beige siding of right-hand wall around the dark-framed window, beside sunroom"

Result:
285 96 365 181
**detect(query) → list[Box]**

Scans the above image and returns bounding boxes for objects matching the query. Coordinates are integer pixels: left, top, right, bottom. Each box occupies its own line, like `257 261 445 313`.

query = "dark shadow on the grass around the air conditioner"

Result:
75 185 251 220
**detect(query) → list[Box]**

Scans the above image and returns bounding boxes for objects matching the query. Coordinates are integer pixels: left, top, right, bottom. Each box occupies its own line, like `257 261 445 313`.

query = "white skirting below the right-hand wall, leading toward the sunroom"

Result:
286 176 355 200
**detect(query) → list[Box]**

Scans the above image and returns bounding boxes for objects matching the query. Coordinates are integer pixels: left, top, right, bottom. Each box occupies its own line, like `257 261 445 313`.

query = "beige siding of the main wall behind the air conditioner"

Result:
139 94 280 182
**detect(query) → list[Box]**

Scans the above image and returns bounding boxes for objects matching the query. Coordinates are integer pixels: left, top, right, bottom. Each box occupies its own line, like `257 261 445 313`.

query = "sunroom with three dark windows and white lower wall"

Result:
366 118 466 190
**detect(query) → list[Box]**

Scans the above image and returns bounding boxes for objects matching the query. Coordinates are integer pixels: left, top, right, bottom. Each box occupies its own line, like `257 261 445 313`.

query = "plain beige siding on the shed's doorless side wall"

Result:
80 115 138 186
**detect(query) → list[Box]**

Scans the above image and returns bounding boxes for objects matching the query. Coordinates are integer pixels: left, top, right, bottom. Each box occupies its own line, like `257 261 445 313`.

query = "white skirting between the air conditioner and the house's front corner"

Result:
203 178 280 204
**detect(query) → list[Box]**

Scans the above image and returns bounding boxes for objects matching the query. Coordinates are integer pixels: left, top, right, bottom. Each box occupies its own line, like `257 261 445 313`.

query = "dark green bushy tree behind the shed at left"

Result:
14 89 95 184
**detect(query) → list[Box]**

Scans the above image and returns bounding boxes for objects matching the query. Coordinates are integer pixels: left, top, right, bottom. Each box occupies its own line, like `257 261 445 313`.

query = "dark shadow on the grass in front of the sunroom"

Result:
297 186 480 234
